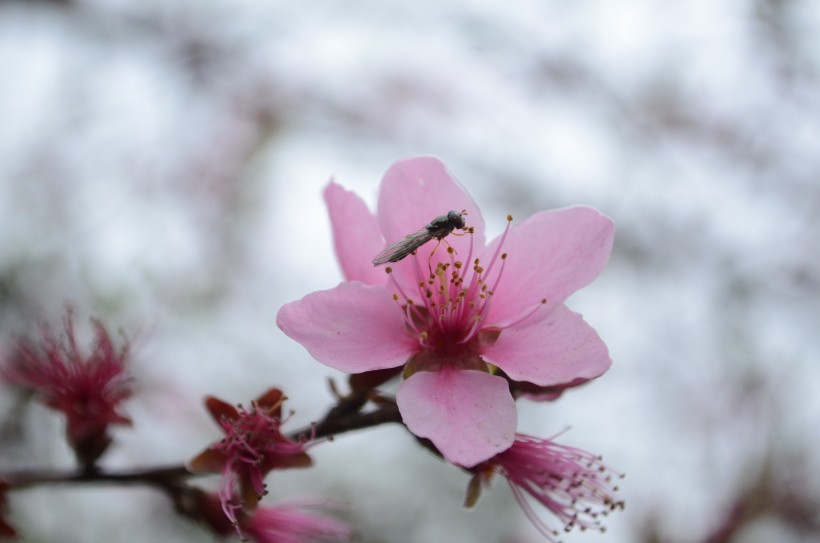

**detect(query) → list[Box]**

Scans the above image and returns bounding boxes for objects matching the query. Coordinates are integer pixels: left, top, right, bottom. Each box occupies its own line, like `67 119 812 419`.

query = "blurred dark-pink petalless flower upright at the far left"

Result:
2 311 131 465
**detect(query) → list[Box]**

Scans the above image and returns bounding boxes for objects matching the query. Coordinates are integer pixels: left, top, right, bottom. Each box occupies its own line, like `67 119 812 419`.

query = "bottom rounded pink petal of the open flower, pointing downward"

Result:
396 370 518 467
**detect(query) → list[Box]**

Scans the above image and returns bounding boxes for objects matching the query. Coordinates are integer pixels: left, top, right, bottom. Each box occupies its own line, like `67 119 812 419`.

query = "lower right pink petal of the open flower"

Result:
481 304 612 386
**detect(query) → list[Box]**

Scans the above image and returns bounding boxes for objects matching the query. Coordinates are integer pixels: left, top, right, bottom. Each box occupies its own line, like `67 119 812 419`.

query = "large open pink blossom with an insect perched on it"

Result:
277 157 613 467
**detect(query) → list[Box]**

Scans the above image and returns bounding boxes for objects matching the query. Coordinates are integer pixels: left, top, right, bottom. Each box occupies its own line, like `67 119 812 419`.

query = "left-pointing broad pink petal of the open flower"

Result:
276 281 418 373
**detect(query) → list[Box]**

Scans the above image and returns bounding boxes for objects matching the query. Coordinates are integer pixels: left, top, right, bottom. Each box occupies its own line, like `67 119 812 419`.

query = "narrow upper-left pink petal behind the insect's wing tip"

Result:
324 180 387 285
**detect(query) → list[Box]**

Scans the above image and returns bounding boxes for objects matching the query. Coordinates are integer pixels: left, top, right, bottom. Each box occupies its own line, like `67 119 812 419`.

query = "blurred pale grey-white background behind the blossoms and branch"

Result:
0 0 820 543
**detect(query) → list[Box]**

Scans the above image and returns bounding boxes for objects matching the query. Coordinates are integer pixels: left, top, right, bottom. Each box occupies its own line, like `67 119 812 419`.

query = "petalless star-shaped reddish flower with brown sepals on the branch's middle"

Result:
189 388 312 524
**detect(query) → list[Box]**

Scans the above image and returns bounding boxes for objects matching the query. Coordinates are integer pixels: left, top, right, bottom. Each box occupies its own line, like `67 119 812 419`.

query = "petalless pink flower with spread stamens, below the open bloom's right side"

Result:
467 434 624 541
